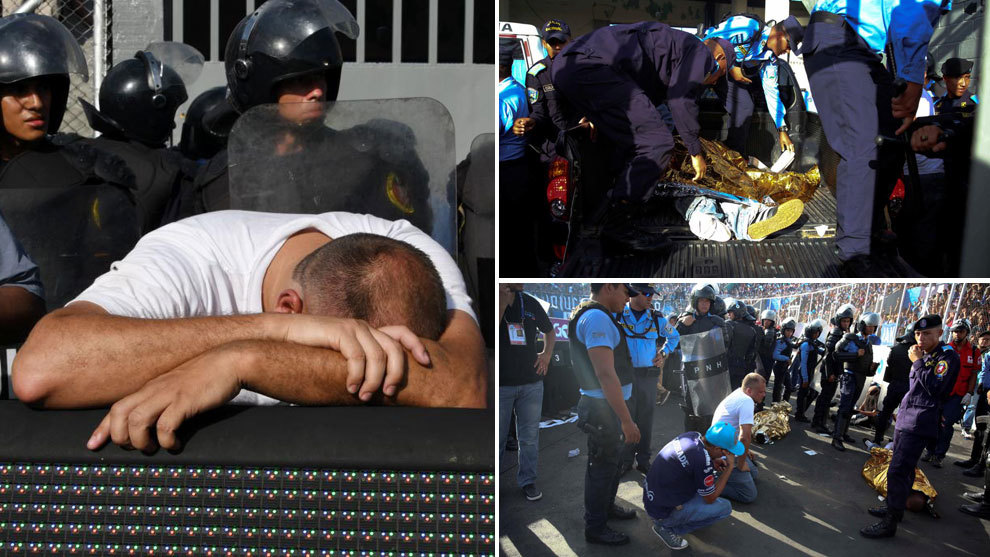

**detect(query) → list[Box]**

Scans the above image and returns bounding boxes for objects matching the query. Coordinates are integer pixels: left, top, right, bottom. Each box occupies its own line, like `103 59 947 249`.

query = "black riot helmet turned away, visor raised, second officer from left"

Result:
80 47 192 147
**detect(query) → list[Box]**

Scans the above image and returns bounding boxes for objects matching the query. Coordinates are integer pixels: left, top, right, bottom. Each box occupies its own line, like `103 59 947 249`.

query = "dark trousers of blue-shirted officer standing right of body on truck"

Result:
802 22 904 260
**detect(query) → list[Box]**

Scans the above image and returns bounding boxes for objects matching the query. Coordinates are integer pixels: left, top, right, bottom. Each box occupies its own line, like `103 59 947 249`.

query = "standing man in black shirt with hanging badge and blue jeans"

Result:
498 284 557 501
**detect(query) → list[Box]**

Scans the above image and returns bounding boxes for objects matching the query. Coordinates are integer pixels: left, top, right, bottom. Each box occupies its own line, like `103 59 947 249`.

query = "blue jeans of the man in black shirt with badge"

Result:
498 381 543 487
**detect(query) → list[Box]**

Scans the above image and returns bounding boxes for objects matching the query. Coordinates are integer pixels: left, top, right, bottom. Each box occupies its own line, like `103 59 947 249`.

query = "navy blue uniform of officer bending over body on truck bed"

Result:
551 22 719 201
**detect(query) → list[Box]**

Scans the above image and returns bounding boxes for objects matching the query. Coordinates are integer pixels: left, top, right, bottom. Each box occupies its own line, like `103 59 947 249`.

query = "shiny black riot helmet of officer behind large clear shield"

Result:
224 0 358 112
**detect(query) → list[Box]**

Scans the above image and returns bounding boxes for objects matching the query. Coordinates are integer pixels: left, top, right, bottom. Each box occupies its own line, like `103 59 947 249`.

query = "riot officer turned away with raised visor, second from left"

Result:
74 45 202 233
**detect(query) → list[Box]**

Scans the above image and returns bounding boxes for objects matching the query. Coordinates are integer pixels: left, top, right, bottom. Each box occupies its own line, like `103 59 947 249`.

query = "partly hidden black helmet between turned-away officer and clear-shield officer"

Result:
179 87 237 160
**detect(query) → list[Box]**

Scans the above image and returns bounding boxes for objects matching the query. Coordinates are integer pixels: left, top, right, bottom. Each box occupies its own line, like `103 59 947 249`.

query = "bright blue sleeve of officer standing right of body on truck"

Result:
887 0 942 83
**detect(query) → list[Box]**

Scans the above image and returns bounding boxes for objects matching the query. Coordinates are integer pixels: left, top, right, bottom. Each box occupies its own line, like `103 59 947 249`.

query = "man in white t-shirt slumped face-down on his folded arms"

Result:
12 211 487 450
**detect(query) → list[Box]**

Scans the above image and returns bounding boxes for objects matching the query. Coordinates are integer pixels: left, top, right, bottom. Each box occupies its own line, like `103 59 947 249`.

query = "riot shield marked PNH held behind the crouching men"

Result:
679 327 732 416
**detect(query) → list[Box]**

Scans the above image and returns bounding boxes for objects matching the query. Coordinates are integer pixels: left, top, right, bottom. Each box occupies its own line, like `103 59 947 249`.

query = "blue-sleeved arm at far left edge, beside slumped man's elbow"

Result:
0 215 45 346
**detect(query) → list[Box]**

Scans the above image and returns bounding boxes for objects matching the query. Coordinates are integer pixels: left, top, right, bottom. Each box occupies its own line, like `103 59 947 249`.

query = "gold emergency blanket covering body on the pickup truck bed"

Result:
660 137 821 203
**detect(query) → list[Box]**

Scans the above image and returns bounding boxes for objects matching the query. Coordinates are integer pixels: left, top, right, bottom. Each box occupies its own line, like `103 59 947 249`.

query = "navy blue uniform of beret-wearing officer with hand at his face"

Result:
887 342 959 512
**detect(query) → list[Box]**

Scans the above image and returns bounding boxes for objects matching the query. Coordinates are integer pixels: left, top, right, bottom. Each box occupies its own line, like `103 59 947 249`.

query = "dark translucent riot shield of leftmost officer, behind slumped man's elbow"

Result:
0 185 141 310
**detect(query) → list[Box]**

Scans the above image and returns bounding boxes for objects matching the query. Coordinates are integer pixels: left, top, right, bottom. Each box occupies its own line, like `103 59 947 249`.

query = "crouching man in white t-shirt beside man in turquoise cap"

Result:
712 373 767 503
